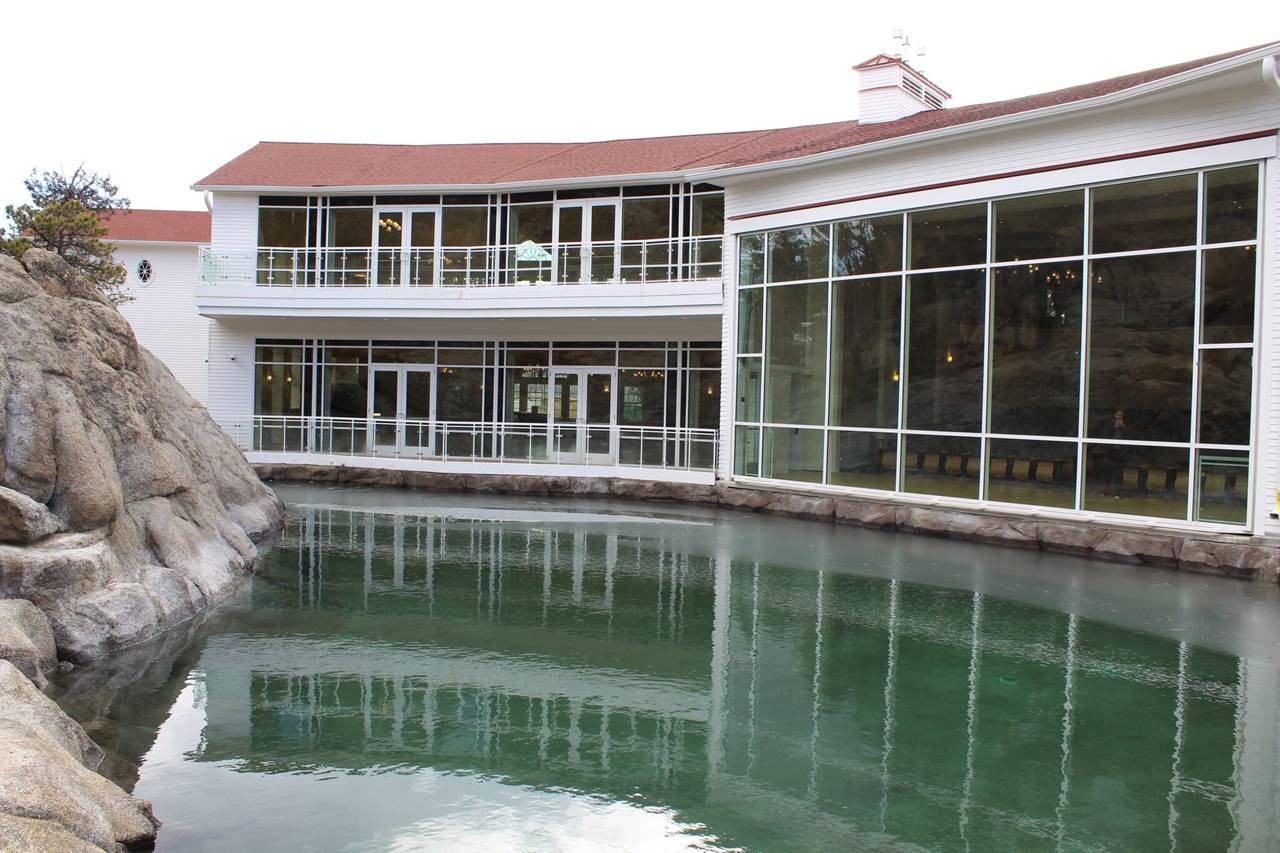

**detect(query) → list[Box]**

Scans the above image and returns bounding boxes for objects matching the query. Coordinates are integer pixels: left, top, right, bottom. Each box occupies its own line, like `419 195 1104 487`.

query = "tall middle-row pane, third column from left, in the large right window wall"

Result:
829 275 902 429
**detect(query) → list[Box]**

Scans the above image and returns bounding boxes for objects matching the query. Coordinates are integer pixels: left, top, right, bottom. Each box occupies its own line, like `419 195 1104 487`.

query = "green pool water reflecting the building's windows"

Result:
52 489 1280 850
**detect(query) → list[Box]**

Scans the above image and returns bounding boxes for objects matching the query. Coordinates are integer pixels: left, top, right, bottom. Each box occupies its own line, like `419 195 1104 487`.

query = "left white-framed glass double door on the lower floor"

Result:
369 364 435 456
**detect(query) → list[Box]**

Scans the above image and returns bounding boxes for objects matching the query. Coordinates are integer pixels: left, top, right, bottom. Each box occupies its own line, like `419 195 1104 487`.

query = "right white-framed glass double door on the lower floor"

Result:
550 368 618 465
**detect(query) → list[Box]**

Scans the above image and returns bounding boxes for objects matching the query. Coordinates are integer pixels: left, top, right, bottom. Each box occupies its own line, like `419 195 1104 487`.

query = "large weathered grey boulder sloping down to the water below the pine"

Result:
0 250 283 661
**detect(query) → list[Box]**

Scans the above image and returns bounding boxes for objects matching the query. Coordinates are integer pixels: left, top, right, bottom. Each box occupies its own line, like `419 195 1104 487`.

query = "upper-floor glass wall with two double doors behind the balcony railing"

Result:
255 183 724 287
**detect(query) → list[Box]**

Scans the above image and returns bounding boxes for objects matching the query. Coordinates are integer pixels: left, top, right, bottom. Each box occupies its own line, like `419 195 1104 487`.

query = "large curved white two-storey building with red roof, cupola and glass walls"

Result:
195 45 1280 533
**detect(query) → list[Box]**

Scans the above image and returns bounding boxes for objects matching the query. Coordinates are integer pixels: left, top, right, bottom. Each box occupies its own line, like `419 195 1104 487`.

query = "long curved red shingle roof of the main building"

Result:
196 47 1274 187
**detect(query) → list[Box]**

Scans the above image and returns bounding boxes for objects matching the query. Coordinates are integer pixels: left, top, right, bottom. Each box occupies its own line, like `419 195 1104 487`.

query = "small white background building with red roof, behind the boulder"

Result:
105 210 210 402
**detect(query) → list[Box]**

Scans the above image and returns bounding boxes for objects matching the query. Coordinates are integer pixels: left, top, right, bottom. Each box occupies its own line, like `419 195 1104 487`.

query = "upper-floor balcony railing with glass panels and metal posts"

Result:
200 236 723 288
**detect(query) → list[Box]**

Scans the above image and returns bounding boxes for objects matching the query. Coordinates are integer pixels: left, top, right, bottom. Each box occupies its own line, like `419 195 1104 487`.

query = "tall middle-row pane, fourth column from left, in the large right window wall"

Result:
906 270 986 433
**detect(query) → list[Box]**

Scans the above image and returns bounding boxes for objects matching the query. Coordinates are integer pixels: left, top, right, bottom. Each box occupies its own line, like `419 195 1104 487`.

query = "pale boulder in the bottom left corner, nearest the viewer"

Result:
0 661 159 850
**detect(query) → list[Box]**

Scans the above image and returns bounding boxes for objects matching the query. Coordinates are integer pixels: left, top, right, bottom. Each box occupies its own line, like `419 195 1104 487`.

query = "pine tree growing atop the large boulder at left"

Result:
0 165 132 305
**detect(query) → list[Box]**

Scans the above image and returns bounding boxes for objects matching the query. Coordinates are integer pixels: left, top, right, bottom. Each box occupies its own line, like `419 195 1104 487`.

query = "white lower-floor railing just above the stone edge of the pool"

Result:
223 415 717 471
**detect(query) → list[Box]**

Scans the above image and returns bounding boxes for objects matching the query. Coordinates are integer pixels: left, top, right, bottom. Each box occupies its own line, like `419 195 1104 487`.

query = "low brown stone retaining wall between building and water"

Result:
255 464 1280 583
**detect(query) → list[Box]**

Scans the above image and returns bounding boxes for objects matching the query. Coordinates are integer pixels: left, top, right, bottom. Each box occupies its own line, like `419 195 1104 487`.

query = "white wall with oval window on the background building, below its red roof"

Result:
115 242 209 402
